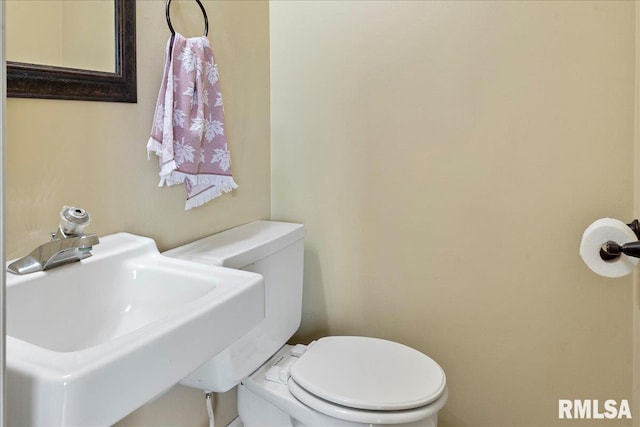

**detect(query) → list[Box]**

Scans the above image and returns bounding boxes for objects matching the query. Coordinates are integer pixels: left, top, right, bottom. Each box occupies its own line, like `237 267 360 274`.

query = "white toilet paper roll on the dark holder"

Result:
580 218 638 277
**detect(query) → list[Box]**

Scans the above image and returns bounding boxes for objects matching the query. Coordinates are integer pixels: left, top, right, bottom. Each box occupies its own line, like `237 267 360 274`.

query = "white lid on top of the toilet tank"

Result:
164 221 305 268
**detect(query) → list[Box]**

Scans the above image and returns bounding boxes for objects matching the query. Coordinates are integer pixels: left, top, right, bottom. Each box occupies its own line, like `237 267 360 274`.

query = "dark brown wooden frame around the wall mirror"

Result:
7 0 137 102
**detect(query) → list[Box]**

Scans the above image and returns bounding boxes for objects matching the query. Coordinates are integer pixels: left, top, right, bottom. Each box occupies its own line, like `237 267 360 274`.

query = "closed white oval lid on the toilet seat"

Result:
290 337 446 411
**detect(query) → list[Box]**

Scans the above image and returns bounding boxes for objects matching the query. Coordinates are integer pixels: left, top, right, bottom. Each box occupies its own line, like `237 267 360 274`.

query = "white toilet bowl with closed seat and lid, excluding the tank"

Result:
238 337 447 427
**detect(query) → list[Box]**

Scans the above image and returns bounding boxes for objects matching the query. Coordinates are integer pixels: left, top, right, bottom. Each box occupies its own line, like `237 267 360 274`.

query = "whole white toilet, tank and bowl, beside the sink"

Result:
164 221 447 427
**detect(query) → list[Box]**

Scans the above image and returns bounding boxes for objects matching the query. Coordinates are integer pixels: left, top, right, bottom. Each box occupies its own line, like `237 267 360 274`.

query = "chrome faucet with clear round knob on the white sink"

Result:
7 206 100 274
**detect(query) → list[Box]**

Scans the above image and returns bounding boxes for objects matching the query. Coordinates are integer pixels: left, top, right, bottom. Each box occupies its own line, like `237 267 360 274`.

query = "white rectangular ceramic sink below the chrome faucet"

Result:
6 233 264 426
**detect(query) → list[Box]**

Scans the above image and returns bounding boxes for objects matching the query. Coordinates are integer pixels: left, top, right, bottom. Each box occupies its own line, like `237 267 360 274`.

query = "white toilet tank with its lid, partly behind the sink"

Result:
164 221 305 392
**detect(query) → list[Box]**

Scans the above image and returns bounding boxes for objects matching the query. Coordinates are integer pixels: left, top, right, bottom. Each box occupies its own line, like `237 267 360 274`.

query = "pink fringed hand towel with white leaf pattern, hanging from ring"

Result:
147 33 238 210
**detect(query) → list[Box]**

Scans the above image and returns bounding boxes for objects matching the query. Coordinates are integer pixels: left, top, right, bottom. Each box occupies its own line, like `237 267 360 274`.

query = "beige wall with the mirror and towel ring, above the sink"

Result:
6 0 270 426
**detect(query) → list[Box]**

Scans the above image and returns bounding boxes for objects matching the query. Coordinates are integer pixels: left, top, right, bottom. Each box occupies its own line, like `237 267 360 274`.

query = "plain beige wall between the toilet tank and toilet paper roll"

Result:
270 1 640 427
